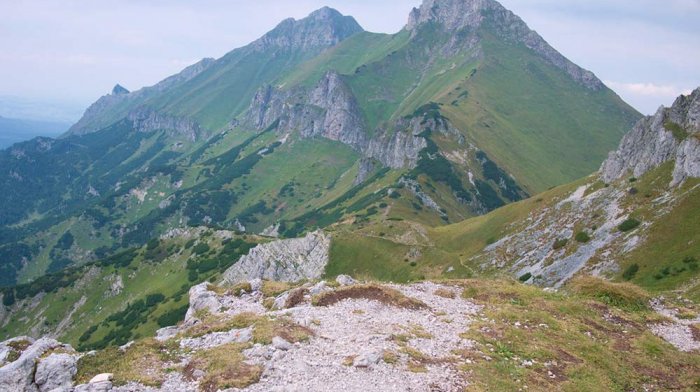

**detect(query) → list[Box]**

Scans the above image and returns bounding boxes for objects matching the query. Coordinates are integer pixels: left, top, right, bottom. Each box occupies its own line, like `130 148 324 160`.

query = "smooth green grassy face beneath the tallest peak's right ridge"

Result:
439 33 639 193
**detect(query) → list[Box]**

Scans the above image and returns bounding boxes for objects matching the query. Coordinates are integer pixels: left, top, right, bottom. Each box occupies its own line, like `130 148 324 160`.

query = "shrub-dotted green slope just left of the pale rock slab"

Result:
0 231 259 347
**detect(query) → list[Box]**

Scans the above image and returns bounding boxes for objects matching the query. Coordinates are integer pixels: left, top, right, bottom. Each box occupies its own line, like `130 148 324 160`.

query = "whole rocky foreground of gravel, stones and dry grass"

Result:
0 276 700 392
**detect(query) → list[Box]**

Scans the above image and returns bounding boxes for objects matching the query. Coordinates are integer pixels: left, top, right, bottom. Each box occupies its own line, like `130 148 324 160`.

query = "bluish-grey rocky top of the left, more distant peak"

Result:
256 7 364 51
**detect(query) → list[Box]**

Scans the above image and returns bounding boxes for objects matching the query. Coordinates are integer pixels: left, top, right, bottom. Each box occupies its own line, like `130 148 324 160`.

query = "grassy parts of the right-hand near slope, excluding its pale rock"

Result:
327 159 700 301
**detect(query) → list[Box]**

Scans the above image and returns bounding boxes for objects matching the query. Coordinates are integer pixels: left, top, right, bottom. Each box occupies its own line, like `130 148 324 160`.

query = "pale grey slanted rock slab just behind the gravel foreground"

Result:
221 231 331 284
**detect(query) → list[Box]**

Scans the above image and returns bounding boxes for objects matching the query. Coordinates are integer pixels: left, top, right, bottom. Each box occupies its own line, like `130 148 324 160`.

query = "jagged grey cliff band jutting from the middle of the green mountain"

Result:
244 72 438 169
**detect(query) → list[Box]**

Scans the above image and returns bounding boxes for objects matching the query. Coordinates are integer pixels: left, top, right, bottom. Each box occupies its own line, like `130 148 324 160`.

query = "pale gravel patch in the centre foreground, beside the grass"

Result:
244 283 480 391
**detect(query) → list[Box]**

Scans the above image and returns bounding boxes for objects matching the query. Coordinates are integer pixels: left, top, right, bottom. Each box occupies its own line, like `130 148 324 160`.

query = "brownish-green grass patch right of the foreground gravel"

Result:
459 279 700 391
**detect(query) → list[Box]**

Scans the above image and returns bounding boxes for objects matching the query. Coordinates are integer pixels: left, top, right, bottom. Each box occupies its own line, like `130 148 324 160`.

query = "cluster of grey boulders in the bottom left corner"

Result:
0 338 78 392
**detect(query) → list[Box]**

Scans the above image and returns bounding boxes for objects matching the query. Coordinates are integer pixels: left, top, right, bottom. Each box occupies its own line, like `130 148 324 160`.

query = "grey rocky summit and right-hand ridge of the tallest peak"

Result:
406 0 605 91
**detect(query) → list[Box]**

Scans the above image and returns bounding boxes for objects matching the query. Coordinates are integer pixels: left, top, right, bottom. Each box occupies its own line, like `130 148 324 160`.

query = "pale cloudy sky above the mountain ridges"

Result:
0 0 700 119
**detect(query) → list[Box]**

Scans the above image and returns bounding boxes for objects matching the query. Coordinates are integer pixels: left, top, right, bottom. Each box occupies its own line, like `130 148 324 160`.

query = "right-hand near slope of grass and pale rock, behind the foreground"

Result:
328 89 700 301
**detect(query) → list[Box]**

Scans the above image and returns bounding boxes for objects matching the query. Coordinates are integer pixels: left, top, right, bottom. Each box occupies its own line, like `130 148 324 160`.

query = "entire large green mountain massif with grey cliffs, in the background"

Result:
0 0 639 285
